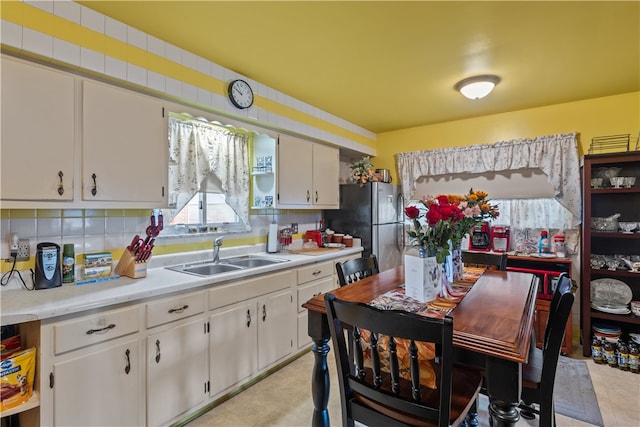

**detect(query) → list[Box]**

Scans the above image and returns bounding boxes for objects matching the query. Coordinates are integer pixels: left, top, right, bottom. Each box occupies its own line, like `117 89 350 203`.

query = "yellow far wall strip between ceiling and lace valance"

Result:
374 92 640 181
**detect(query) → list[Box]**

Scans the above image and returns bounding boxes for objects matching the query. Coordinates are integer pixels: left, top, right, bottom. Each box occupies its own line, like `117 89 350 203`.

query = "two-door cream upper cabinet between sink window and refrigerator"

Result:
277 135 340 209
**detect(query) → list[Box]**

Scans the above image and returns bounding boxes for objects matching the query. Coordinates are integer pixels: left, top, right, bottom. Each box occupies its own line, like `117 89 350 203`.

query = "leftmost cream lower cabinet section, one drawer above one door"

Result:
40 305 144 427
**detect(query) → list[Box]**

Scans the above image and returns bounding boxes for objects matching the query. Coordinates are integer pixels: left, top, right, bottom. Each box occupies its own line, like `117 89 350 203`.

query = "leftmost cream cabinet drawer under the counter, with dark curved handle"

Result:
53 306 139 354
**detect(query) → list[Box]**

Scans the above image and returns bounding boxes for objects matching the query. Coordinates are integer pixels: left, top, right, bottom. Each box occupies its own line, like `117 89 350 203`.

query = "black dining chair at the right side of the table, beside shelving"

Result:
519 273 577 427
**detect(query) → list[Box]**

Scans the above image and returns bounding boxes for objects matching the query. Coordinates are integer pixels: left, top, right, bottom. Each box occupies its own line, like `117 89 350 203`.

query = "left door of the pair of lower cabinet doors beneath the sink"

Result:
209 300 258 396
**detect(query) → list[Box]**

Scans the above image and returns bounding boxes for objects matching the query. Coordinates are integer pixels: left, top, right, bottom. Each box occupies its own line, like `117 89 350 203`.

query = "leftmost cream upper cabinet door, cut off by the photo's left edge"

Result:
0 57 74 200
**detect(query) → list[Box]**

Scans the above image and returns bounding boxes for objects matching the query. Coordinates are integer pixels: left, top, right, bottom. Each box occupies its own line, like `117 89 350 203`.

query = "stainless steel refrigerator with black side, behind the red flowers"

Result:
323 182 405 271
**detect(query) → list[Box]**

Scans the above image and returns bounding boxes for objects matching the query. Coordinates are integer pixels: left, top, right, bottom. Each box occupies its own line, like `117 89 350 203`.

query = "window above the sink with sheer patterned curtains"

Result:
169 113 252 234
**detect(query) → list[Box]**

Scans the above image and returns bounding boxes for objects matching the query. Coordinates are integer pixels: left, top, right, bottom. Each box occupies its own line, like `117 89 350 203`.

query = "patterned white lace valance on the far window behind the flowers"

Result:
397 133 582 228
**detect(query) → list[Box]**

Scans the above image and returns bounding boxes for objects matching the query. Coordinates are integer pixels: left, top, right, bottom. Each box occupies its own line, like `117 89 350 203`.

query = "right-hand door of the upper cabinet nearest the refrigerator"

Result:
313 144 340 208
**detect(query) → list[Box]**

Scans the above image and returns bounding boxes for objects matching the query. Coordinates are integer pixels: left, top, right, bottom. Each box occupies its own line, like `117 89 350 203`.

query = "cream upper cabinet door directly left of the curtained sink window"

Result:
82 81 168 207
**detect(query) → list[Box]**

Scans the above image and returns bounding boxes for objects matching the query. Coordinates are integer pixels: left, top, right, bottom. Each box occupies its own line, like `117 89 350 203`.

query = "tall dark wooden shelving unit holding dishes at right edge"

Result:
580 151 640 356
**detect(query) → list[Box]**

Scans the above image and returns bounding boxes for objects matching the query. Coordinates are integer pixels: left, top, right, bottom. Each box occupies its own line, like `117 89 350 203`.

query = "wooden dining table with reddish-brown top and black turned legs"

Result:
303 266 538 427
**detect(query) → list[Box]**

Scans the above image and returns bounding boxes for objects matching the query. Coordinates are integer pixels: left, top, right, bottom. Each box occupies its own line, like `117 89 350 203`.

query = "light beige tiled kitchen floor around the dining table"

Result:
189 345 640 427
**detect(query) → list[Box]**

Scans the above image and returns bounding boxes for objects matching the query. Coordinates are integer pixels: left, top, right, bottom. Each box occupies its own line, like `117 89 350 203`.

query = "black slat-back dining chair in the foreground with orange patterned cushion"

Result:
325 293 482 427
